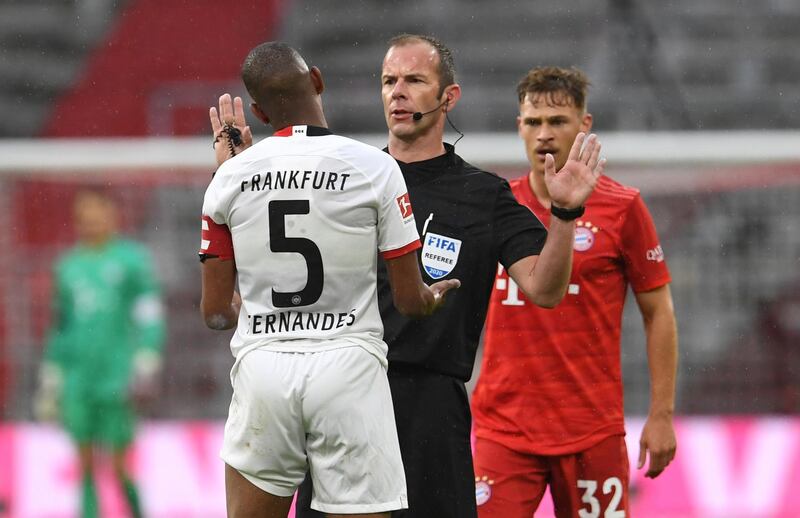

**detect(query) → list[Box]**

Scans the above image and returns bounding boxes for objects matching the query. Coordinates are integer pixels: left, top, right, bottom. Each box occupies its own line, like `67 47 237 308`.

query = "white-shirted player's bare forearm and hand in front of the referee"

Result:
386 252 461 317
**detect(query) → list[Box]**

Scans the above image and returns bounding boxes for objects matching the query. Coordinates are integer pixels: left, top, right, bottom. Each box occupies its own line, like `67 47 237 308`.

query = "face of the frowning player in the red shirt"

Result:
517 93 592 180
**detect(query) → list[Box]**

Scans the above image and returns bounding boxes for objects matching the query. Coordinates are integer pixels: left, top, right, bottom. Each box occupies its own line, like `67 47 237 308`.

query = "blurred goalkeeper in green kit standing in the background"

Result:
34 191 165 518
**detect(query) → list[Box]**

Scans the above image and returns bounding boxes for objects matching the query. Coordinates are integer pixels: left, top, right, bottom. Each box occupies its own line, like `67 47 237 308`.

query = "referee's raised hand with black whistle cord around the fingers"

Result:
208 94 253 166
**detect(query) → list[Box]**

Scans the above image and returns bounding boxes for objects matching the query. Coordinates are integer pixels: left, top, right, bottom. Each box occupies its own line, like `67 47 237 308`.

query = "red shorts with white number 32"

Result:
474 435 630 518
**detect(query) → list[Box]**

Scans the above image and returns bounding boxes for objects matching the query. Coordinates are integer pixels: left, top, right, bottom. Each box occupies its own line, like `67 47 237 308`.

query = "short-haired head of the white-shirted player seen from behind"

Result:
242 41 319 115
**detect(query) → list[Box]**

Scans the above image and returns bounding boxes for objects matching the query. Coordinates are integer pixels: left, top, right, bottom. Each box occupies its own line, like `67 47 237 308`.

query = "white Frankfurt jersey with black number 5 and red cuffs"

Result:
200 126 420 362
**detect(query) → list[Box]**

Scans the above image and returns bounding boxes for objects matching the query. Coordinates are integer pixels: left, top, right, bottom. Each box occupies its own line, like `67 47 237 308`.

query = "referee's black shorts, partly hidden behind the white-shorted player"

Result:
297 364 477 518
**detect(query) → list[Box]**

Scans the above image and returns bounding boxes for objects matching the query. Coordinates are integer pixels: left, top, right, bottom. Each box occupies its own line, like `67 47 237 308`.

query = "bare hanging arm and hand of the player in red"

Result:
636 284 678 478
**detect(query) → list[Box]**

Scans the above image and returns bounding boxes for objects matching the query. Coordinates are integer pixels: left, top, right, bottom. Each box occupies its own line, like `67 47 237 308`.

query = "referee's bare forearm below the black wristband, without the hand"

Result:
509 217 575 308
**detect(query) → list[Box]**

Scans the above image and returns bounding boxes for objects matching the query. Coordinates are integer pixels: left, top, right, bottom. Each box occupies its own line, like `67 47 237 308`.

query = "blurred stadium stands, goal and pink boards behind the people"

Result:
0 0 800 518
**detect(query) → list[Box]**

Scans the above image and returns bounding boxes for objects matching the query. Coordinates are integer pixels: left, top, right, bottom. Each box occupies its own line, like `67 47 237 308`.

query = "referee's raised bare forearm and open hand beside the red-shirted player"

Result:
508 133 605 308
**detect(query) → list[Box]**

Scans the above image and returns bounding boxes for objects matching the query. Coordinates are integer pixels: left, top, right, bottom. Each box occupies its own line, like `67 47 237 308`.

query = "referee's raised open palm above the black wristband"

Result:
544 132 605 209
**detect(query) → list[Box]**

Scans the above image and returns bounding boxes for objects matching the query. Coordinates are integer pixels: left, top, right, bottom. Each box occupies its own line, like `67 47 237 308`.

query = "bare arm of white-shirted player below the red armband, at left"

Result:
200 257 242 330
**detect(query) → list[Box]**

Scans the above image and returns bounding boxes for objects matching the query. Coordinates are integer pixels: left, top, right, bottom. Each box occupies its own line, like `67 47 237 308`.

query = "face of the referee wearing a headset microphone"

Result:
381 42 444 140
